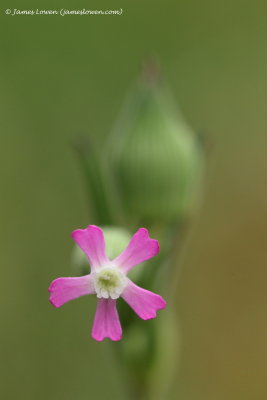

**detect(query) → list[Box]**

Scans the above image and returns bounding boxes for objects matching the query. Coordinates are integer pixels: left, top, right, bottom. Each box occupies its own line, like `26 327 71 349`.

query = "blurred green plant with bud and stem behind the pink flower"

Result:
73 66 204 399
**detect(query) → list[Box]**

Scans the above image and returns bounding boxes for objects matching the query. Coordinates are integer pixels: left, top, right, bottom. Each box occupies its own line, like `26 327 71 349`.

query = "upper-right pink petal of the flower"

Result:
114 228 159 272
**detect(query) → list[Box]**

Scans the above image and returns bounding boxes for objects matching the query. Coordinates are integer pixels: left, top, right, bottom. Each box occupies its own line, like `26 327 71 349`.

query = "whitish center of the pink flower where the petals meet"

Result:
93 265 127 299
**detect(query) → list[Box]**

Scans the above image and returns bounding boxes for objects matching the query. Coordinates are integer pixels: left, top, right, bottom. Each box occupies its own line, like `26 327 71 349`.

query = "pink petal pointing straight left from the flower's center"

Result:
48 275 95 307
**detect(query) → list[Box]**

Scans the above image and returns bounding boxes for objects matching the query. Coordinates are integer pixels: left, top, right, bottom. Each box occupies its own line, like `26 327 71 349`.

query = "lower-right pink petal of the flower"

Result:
121 279 166 320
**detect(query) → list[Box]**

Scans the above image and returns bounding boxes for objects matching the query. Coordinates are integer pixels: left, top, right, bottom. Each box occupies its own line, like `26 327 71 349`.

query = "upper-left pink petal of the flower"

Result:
71 225 109 269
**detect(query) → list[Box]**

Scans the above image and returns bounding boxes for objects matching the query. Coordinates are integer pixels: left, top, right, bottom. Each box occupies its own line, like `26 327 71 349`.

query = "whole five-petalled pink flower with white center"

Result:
48 225 166 341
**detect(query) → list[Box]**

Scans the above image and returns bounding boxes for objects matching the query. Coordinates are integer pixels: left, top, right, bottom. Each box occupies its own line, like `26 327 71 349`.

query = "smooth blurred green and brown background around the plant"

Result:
0 0 267 400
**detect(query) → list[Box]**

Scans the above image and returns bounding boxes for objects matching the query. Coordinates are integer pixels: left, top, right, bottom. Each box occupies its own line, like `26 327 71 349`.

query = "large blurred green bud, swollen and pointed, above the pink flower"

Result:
106 69 203 223
